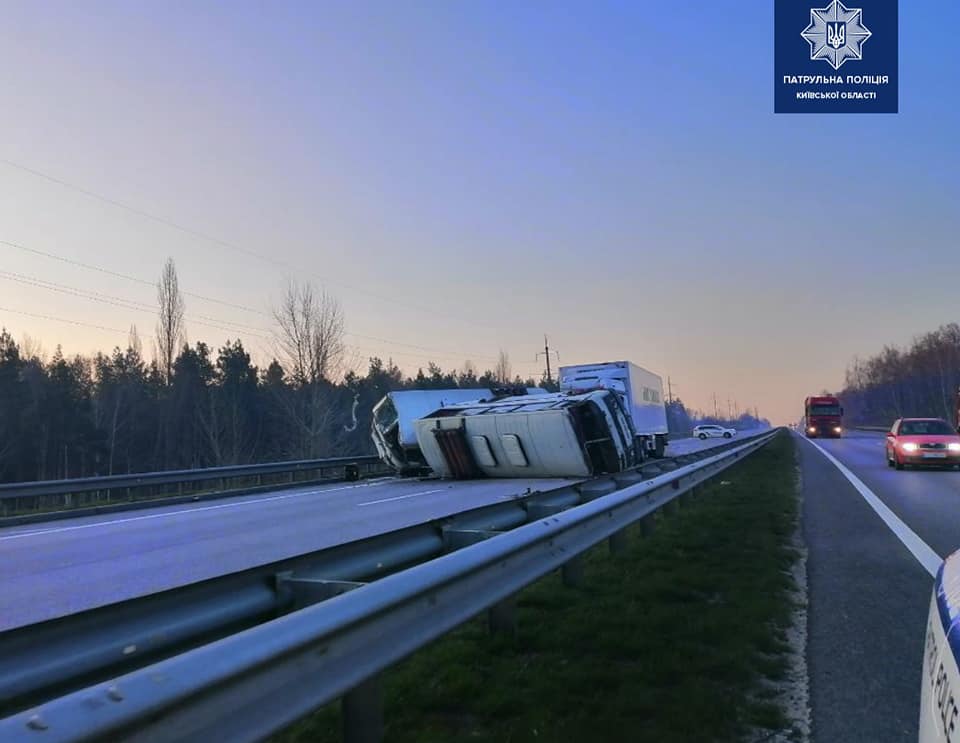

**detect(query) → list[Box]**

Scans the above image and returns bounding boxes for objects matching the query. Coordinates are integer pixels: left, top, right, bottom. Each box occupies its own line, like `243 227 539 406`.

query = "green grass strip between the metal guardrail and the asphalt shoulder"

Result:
275 434 796 743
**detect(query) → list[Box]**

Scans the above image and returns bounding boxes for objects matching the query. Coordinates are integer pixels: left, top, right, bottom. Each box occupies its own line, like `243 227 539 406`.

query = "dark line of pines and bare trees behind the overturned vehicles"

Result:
0 261 753 482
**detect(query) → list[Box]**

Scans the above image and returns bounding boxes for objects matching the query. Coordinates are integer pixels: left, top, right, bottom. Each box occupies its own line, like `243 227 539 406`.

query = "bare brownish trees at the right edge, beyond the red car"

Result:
838 323 960 426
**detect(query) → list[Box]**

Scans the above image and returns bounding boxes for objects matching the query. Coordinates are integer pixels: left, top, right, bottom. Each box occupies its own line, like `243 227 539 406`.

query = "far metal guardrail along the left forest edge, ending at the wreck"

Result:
0 455 383 516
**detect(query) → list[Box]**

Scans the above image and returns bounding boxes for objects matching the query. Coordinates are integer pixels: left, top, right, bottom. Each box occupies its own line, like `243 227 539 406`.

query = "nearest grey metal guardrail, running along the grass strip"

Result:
0 430 777 742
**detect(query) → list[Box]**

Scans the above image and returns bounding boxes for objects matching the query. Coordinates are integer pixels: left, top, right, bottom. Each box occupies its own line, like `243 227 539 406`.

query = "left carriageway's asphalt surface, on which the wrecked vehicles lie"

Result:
0 430 764 631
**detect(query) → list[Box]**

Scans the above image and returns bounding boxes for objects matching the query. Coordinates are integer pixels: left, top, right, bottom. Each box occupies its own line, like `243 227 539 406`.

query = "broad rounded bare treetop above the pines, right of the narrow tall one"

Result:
273 280 346 385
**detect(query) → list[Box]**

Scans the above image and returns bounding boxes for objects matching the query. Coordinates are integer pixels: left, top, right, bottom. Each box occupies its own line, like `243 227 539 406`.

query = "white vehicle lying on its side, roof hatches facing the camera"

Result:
414 390 642 479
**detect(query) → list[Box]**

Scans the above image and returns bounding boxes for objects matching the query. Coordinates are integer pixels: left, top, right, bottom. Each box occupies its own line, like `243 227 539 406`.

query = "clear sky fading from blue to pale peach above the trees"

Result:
0 0 960 423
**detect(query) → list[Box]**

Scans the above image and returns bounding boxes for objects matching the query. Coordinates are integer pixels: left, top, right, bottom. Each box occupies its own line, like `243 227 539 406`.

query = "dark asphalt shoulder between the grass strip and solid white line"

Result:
798 441 932 743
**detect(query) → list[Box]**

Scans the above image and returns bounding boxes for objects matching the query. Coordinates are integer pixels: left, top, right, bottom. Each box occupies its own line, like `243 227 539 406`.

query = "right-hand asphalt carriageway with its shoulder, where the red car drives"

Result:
798 432 960 743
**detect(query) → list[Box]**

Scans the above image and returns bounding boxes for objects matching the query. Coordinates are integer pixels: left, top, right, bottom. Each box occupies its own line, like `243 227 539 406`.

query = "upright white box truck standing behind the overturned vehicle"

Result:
559 361 669 457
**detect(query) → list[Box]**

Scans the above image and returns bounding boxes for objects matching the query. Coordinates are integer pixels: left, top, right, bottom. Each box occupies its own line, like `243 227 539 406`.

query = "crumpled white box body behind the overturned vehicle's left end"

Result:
370 387 547 474
